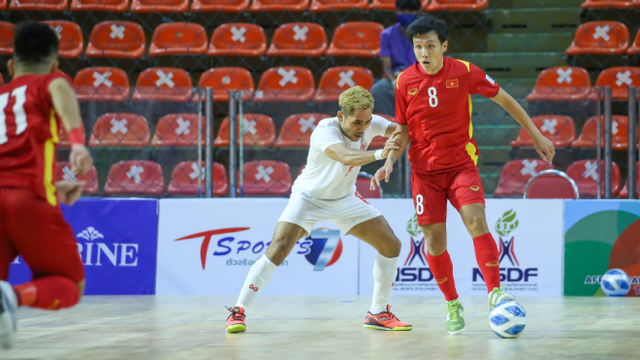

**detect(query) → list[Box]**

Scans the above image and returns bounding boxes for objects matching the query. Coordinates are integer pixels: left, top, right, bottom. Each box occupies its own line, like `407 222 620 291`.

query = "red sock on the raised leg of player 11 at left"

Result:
13 275 80 310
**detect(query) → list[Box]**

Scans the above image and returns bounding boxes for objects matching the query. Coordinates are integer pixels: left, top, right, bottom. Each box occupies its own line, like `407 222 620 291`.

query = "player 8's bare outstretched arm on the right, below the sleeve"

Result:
491 88 556 164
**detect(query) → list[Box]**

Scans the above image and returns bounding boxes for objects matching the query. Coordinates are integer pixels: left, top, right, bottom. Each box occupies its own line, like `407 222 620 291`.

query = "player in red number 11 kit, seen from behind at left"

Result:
0 23 93 349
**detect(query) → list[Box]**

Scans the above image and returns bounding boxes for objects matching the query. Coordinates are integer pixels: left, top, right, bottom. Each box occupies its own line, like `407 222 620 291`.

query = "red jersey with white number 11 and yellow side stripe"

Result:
0 72 72 205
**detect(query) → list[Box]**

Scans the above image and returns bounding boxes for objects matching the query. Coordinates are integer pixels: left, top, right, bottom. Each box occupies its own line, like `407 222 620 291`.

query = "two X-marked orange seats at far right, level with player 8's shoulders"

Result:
527 66 640 101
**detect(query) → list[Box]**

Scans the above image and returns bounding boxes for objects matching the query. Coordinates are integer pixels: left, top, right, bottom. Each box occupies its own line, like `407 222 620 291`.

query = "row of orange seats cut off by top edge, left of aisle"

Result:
0 0 488 13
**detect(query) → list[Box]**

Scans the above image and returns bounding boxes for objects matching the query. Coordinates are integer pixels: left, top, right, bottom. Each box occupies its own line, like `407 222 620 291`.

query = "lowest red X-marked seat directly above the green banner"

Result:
567 159 620 198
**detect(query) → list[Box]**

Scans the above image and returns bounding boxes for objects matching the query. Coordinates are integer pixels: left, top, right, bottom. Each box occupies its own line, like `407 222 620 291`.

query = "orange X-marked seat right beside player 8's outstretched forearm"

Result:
511 115 576 148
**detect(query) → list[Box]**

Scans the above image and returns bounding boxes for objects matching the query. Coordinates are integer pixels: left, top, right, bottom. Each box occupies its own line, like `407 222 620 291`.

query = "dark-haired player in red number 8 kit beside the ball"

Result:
371 17 555 334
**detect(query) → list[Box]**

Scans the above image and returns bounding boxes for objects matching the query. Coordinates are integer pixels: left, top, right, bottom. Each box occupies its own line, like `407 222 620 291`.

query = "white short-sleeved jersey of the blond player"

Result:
291 115 392 200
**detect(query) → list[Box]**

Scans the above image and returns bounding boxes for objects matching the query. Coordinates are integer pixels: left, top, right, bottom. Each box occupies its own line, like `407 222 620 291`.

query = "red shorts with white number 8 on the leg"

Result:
411 167 484 225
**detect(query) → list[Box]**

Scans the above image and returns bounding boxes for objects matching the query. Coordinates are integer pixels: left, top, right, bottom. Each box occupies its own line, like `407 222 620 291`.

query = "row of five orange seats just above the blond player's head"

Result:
74 66 374 102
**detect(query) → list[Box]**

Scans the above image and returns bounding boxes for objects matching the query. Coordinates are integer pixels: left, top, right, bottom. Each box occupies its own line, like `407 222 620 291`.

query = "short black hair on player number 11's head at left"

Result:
13 22 60 66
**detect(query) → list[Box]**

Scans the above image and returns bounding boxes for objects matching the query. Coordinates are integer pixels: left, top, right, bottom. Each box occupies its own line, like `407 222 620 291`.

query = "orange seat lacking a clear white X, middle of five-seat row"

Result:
198 67 255 102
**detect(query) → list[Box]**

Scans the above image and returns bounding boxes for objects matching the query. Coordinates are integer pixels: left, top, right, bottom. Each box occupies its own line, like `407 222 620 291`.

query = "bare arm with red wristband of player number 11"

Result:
49 78 93 175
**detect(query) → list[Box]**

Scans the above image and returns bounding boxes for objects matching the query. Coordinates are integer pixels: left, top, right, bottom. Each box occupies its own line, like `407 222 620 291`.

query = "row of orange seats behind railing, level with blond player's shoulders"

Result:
60 113 394 148
